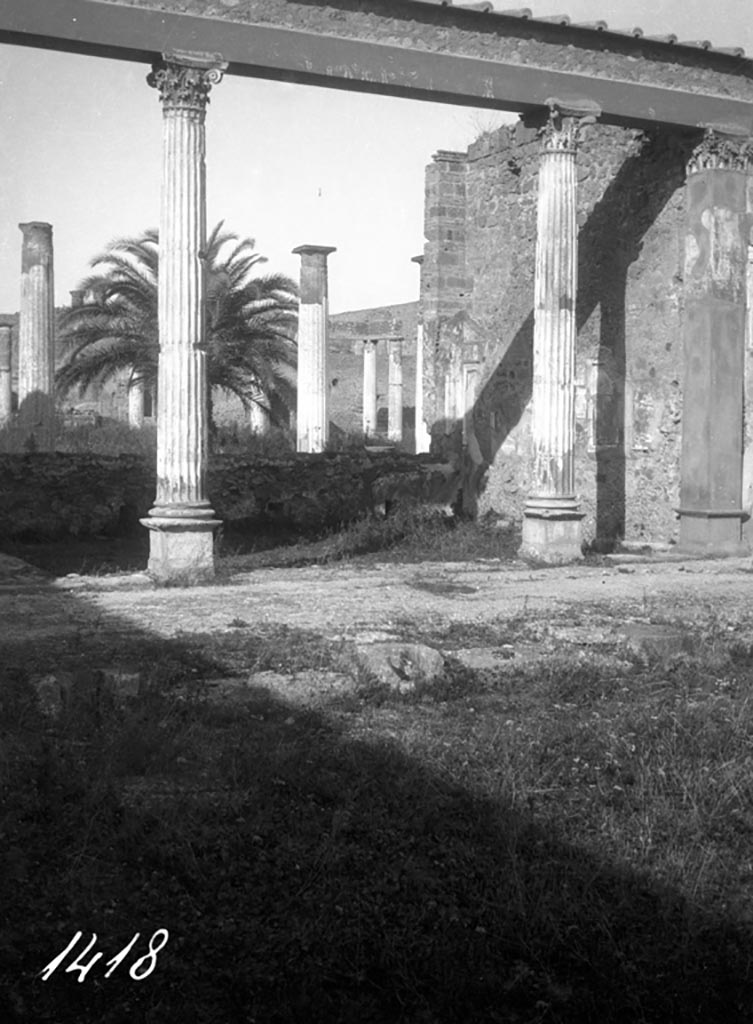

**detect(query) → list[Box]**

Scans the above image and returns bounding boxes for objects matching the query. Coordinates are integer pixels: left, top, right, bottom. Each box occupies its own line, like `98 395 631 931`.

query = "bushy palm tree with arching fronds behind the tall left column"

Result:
55 221 298 422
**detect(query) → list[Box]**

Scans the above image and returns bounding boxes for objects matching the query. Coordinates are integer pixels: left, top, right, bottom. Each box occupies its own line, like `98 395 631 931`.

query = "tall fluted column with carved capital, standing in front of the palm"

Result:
141 53 226 583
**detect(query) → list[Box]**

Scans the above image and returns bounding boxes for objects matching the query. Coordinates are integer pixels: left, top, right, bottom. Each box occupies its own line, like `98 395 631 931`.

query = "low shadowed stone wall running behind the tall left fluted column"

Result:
0 451 458 541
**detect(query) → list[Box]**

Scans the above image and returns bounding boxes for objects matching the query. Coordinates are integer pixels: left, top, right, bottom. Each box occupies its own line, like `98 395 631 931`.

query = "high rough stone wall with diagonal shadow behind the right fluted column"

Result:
422 124 688 547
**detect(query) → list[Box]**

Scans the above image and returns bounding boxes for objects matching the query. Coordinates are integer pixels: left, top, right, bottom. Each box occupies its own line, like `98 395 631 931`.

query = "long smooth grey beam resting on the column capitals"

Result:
0 0 753 134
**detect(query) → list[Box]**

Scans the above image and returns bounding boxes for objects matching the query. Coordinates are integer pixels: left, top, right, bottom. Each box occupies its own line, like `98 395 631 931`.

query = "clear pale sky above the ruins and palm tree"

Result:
0 0 753 312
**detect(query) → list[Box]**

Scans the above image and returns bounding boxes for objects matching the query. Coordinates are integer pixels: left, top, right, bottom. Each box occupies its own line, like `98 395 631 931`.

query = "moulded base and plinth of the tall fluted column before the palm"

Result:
140 508 220 586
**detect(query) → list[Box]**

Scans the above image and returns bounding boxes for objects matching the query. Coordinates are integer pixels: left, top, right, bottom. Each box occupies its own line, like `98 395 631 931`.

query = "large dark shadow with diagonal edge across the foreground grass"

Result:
0 573 753 1024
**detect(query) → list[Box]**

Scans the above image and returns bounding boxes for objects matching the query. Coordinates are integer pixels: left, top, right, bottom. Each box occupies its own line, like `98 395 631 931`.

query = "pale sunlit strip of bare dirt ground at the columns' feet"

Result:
0 555 753 645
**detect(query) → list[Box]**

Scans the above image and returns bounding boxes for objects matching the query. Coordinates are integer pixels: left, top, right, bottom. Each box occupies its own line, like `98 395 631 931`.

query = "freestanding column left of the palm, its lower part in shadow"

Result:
18 220 55 452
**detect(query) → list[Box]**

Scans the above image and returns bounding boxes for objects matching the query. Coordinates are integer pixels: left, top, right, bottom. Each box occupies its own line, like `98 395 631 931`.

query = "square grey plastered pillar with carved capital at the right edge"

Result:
679 129 753 554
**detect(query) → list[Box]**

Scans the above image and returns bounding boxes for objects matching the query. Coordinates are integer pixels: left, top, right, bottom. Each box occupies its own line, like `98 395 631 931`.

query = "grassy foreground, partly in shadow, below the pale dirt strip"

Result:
0 616 753 1024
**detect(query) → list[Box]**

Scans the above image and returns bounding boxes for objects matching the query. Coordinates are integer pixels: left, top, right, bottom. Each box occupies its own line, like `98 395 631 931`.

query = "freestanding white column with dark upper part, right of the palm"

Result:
293 246 336 452
